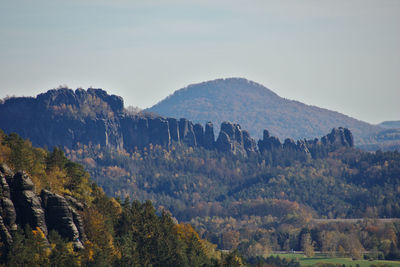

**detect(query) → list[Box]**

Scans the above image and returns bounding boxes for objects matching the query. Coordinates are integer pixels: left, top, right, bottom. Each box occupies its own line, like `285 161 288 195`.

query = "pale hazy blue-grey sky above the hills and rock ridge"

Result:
0 0 400 123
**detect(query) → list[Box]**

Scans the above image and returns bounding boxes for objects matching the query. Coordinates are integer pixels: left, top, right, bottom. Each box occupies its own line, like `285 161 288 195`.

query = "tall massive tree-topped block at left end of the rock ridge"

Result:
0 89 123 148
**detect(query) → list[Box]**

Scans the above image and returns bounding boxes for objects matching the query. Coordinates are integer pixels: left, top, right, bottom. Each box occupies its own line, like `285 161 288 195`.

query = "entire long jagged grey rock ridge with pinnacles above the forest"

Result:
0 89 354 156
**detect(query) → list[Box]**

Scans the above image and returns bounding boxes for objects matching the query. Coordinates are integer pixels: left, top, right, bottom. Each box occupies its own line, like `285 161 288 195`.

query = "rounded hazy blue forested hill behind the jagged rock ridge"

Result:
146 78 382 144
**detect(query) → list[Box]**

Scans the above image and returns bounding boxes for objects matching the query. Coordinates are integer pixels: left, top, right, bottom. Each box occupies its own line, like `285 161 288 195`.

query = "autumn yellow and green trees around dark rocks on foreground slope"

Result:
0 131 245 266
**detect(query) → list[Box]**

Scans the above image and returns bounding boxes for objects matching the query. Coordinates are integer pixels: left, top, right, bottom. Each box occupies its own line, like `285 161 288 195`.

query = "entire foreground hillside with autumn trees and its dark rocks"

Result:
0 131 243 266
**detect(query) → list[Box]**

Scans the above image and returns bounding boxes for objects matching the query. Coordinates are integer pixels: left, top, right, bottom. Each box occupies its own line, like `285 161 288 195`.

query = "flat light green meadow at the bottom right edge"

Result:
272 254 400 267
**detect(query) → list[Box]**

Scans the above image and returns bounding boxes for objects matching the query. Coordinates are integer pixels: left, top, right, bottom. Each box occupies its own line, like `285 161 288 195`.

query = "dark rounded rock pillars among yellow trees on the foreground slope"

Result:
0 164 86 249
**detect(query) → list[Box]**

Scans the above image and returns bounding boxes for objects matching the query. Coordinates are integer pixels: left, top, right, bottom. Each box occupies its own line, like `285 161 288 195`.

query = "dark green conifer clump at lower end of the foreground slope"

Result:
116 201 214 266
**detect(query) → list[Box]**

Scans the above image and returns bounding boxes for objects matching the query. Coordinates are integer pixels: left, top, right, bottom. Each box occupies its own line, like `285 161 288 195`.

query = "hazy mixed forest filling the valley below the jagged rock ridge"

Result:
65 140 400 258
